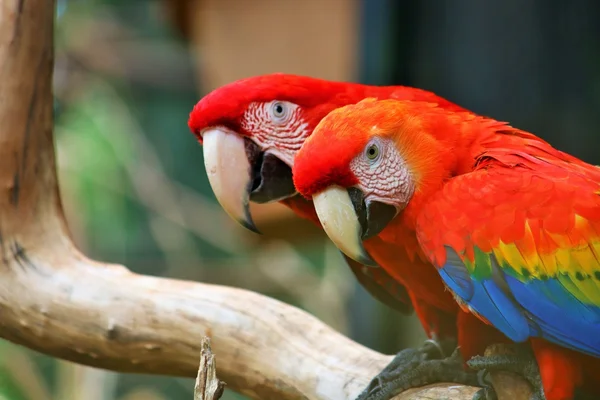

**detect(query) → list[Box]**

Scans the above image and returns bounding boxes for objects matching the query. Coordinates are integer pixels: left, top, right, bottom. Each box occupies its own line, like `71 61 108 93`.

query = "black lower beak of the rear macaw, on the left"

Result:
245 139 296 203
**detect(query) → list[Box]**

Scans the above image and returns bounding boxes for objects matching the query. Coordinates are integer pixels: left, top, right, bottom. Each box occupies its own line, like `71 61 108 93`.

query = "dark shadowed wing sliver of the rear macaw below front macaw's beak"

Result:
342 253 413 315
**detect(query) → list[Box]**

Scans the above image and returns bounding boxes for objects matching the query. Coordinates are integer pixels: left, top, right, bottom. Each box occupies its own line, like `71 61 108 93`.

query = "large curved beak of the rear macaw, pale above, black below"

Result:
202 128 296 233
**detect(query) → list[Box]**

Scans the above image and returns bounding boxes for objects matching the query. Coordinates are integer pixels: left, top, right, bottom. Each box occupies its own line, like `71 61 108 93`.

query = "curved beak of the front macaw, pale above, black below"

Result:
313 186 397 267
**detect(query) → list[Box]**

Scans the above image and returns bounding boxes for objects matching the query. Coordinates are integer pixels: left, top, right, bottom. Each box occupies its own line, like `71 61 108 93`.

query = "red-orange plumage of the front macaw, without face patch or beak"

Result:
293 97 600 400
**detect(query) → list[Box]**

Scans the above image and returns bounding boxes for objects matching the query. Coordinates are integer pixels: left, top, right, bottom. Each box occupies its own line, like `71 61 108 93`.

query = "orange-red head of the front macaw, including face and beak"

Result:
293 98 475 265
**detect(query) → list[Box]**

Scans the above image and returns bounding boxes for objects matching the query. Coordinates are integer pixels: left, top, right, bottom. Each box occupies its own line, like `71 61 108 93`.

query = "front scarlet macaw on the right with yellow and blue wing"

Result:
293 99 600 400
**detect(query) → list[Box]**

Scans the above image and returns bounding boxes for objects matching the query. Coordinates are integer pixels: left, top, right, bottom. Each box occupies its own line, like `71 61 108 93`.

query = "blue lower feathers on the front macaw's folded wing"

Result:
439 247 600 357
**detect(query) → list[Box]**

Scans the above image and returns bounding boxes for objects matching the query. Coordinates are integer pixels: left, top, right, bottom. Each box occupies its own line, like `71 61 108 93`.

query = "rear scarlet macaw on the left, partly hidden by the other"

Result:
188 74 487 396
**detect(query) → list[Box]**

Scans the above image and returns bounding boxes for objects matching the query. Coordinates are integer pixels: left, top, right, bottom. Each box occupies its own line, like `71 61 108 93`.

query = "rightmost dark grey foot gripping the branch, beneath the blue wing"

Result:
467 345 546 400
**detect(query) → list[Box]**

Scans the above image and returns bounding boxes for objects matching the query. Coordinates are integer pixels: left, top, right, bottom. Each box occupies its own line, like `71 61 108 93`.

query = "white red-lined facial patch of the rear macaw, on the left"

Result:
241 100 310 167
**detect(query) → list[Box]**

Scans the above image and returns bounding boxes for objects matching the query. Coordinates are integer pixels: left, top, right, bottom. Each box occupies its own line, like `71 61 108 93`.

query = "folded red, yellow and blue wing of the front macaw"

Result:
417 151 600 356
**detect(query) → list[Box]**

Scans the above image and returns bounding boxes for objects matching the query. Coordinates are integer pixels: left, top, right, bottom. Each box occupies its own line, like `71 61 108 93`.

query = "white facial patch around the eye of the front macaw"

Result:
350 138 415 209
